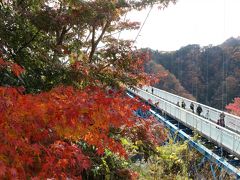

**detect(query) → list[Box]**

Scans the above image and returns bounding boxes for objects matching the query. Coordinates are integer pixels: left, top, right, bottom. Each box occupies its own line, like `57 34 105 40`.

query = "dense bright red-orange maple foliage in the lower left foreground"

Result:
0 87 144 179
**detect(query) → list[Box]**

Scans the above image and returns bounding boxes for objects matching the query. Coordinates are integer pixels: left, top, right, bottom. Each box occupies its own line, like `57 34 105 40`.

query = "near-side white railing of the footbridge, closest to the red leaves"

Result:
129 89 240 157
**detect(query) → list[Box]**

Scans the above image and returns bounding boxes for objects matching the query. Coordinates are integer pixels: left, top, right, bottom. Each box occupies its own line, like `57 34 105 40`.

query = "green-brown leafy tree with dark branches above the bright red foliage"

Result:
0 0 175 92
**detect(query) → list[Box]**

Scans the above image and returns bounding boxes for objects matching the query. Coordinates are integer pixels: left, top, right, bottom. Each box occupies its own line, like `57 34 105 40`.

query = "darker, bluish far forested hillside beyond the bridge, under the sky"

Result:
145 38 240 109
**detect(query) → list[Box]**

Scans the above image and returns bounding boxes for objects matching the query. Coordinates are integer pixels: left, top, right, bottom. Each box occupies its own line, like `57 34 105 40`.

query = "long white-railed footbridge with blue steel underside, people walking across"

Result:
127 86 240 179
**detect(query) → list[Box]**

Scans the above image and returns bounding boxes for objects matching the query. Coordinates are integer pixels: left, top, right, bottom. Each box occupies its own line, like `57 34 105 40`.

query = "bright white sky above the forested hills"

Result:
121 0 240 51
